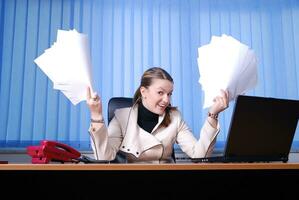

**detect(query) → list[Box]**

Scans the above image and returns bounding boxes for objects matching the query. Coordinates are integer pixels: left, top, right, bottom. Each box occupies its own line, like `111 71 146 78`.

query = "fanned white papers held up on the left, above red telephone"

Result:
34 30 92 105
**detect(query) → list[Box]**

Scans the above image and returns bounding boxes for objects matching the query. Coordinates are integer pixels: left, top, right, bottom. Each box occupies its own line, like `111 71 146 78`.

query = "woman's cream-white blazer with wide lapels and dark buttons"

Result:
89 105 219 163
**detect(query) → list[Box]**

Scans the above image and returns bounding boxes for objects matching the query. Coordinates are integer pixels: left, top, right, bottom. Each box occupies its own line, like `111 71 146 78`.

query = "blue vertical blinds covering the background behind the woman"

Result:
0 0 299 149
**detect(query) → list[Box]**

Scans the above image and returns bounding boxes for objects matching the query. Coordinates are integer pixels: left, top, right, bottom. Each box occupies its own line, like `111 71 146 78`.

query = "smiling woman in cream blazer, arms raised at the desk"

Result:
87 67 228 163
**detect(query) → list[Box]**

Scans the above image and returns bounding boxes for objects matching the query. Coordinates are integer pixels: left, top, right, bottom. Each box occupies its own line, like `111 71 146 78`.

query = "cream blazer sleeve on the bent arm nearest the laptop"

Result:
176 113 220 158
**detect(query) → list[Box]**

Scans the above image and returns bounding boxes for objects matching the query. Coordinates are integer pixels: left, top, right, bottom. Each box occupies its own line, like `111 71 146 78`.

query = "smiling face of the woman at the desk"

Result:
140 79 173 115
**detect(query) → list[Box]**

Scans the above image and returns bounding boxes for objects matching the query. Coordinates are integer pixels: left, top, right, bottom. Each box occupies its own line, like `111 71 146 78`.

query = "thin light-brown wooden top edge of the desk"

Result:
0 163 299 171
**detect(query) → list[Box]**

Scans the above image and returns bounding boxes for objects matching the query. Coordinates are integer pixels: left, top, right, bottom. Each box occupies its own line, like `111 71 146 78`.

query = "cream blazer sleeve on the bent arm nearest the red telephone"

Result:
89 117 123 160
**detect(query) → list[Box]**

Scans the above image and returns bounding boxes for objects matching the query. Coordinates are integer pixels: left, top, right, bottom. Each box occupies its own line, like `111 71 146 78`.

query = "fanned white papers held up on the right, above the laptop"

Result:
197 35 258 108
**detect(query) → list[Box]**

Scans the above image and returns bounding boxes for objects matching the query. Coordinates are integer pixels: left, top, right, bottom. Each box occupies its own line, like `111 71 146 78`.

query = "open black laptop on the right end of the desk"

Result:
191 95 299 163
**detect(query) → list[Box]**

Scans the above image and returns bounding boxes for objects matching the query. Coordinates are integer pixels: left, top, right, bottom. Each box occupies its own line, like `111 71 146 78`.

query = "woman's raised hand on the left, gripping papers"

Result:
86 87 103 120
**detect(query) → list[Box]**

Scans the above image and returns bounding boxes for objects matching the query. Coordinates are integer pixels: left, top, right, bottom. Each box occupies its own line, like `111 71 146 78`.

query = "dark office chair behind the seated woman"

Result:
108 97 176 163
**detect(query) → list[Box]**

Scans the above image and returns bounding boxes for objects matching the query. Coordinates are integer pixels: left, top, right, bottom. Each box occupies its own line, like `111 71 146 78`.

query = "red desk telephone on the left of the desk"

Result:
27 140 81 164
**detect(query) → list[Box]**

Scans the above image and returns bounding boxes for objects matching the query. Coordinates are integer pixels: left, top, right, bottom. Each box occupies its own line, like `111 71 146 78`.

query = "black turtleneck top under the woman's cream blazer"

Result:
137 103 159 133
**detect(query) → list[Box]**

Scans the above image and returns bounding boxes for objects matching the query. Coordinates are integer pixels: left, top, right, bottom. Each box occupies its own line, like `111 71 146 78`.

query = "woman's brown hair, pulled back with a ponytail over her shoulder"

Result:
133 67 176 127
